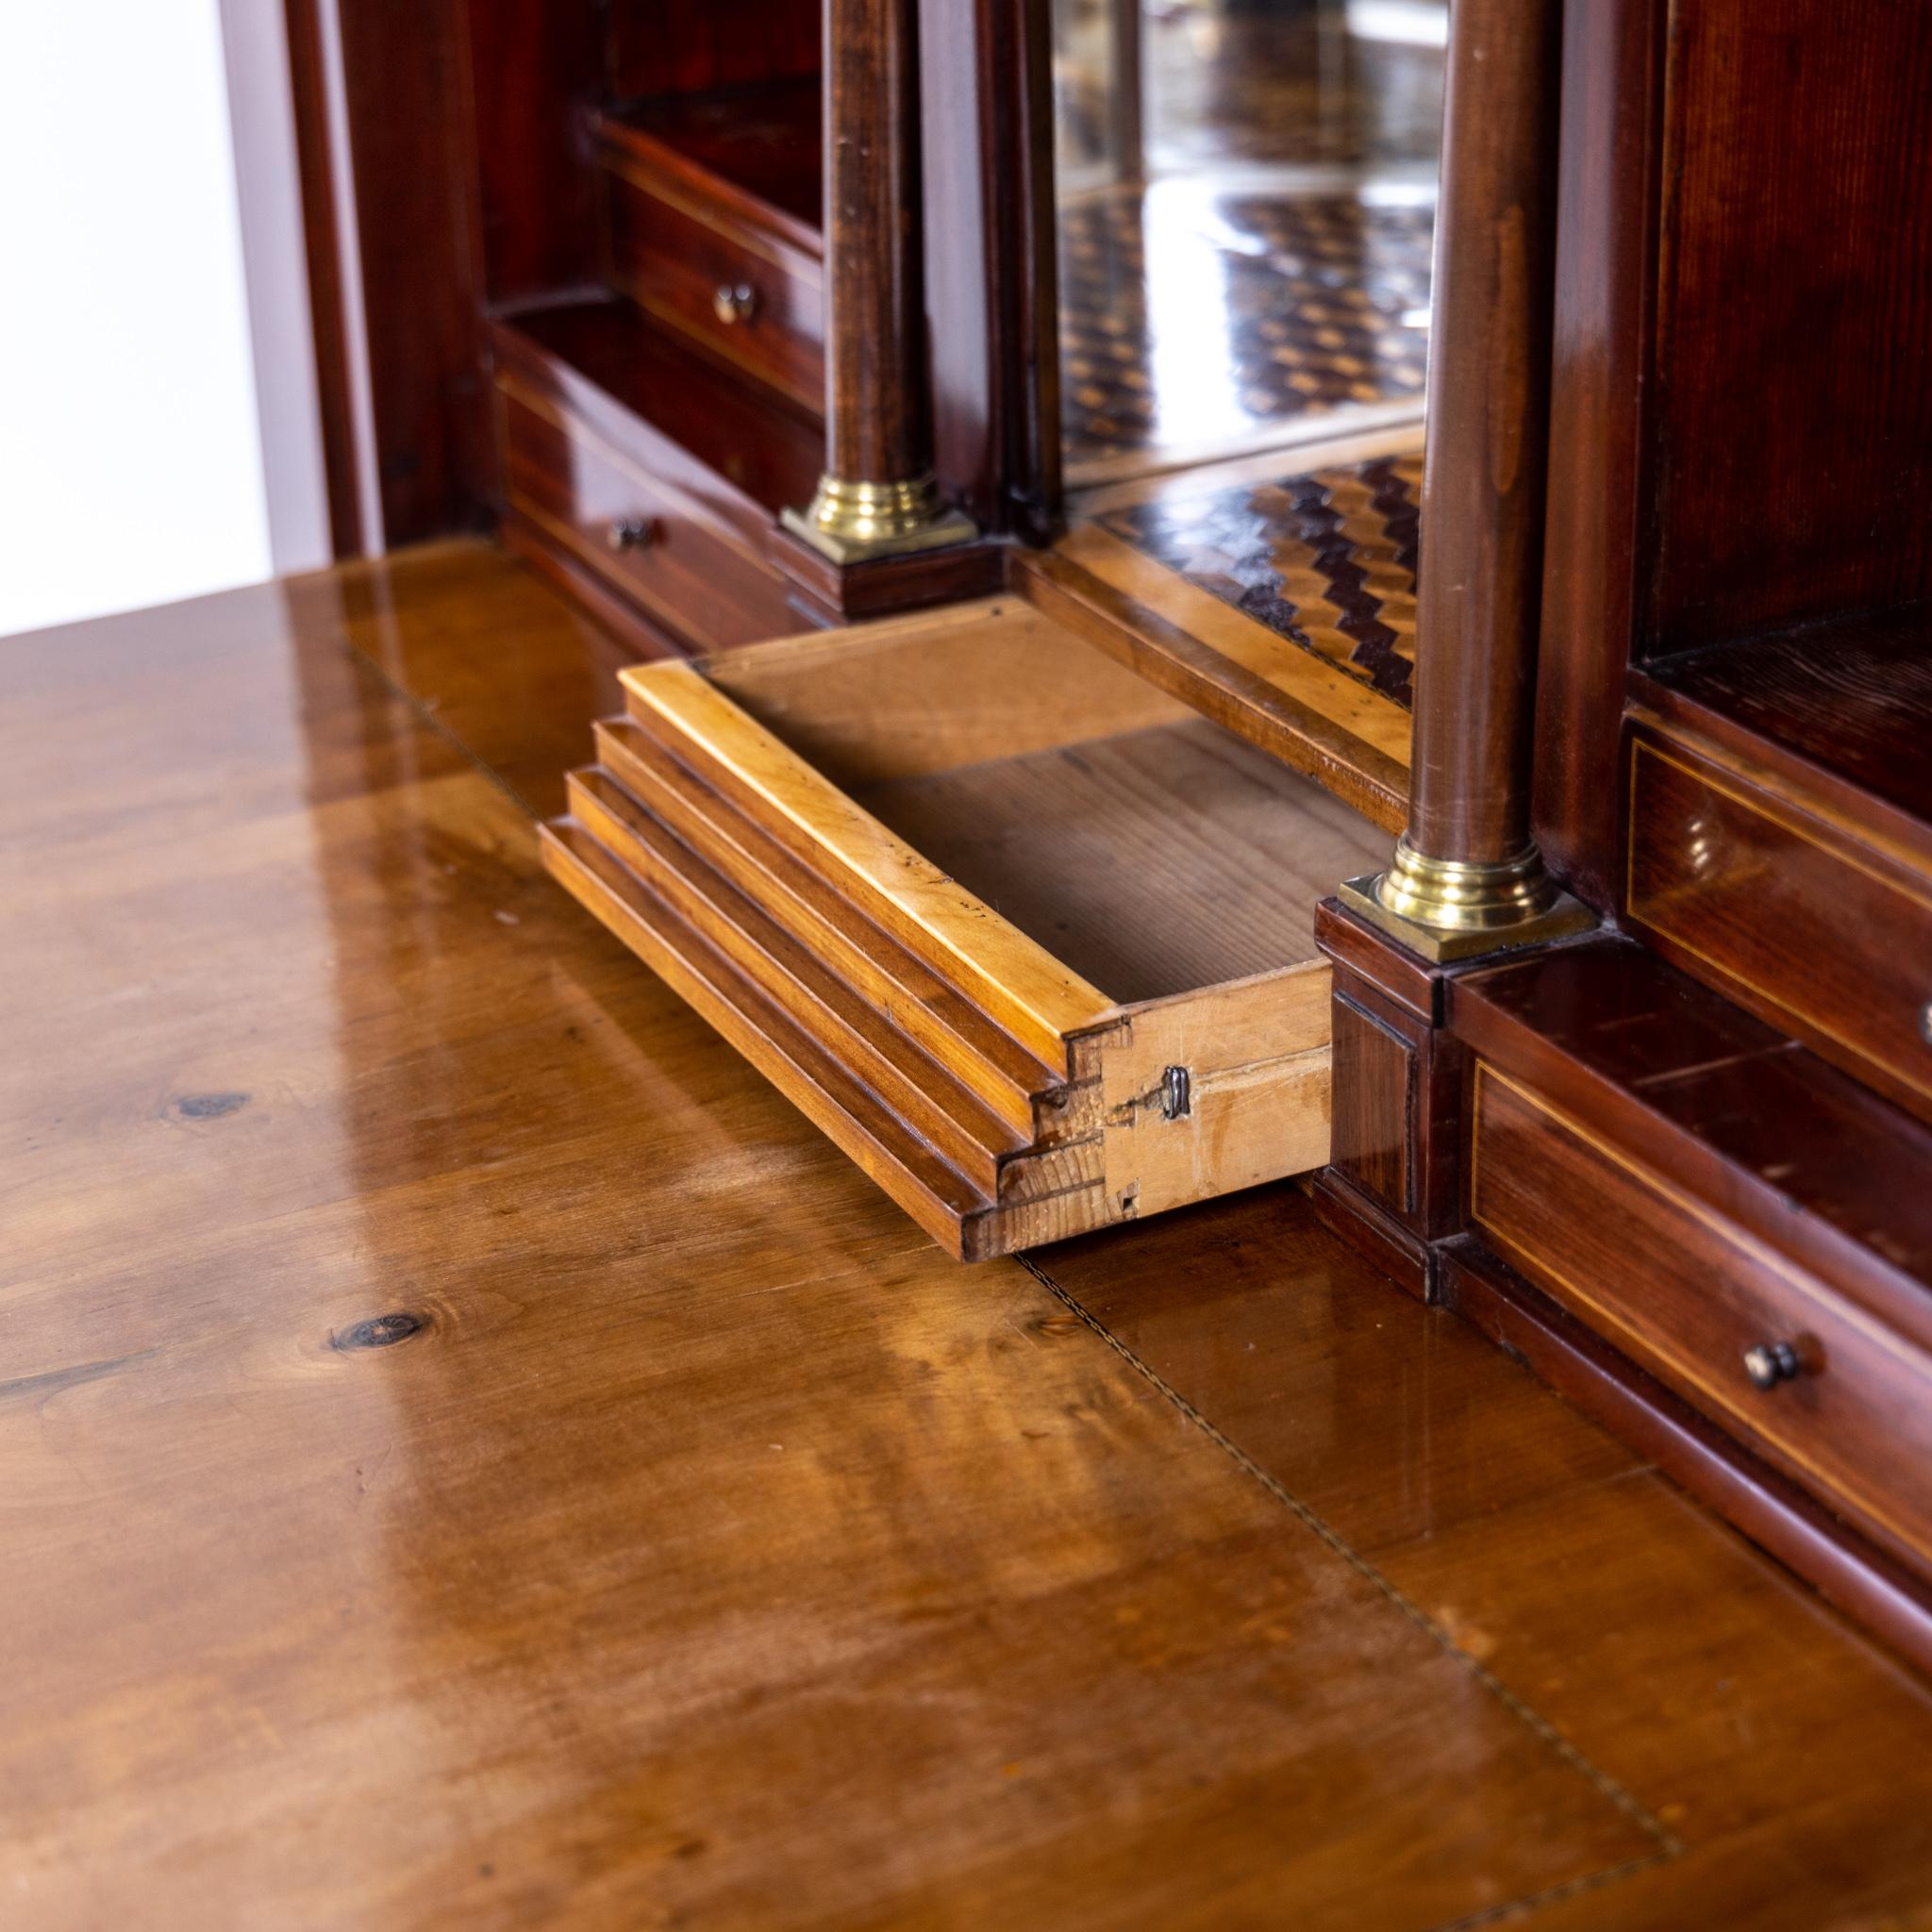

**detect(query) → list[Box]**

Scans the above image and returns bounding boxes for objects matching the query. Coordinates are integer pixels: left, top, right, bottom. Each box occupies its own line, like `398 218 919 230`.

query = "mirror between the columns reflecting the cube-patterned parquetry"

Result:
1053 0 1449 487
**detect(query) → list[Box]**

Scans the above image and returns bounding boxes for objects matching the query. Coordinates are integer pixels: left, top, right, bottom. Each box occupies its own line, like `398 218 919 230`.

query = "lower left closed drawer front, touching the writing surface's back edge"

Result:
496 380 798 647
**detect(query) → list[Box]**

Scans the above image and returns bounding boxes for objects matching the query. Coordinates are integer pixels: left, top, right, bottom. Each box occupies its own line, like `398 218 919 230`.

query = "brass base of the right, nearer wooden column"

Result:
1339 835 1596 964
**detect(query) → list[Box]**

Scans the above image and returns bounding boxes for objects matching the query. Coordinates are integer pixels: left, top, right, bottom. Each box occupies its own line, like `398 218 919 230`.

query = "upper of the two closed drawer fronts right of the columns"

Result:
1626 734 1932 1119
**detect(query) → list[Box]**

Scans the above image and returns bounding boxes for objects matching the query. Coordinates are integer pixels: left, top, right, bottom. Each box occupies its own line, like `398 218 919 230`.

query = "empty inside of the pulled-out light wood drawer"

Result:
711 603 1387 1003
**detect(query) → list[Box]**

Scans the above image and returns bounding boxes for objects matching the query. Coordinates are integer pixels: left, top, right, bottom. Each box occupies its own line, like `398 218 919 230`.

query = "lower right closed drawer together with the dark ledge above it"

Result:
1447 941 1932 1630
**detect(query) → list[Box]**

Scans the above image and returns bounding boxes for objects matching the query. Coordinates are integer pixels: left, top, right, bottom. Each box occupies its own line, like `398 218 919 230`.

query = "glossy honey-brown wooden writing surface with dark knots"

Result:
11 547 1932 1932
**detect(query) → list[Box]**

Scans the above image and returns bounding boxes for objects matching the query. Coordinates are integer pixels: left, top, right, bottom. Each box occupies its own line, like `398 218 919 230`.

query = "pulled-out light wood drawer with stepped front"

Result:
545 597 1387 1259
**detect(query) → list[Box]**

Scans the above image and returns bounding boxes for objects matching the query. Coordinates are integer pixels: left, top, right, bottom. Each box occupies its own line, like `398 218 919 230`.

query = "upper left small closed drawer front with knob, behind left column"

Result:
605 163 824 411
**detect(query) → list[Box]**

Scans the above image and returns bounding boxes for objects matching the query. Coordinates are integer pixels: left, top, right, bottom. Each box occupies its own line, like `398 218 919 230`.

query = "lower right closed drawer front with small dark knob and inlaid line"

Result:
1471 1064 1932 1565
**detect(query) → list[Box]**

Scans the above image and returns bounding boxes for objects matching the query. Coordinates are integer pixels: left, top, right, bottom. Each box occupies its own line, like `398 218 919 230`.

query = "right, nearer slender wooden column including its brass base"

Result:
1342 0 1591 958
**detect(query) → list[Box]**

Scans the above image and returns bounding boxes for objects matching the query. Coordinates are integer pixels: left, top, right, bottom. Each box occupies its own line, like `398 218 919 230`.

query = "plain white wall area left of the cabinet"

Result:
0 0 279 634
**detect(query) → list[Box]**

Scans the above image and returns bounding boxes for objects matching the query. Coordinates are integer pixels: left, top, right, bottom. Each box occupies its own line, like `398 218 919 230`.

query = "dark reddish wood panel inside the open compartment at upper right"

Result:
1642 0 1932 653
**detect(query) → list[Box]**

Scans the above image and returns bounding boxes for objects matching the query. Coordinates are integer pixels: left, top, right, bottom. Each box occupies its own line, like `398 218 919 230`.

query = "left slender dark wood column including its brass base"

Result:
784 0 975 564
